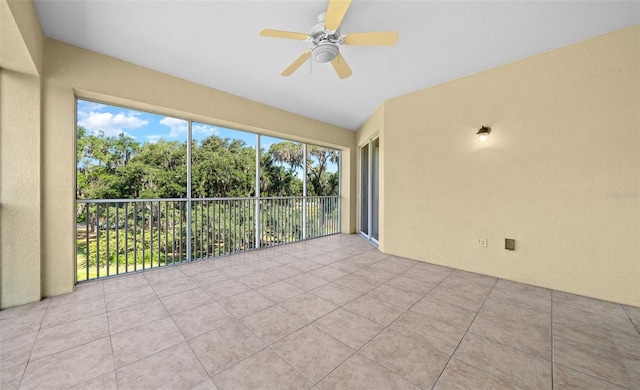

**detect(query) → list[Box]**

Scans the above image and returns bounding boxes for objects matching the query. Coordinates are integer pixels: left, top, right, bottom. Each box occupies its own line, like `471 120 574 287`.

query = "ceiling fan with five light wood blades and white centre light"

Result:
260 0 398 79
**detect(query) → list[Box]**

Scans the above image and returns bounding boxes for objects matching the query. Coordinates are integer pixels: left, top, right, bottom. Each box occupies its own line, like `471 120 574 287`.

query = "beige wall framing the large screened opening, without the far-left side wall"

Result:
43 39 355 296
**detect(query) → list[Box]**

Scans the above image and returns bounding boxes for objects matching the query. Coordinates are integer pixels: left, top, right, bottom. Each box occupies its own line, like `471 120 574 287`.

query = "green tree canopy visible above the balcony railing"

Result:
76 126 339 199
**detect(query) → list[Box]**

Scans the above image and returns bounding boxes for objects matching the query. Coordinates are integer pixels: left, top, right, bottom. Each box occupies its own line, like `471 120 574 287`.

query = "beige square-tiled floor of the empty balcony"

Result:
0 235 640 390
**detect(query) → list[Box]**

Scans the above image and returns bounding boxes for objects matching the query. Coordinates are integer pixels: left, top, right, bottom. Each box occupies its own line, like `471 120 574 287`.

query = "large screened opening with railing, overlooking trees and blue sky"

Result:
76 100 340 280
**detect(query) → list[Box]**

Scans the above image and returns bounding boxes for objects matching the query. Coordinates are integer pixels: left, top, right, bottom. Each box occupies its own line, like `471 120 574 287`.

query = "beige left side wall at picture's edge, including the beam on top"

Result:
0 1 43 308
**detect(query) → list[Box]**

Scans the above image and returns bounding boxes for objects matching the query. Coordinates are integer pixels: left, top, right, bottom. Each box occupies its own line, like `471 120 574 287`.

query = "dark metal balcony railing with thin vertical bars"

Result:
76 196 340 281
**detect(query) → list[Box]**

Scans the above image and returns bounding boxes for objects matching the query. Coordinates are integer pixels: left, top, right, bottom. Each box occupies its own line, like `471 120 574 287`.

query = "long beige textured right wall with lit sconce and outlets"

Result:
372 25 640 305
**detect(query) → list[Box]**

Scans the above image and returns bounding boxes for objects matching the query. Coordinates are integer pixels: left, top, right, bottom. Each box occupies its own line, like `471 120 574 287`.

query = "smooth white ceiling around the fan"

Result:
34 0 640 130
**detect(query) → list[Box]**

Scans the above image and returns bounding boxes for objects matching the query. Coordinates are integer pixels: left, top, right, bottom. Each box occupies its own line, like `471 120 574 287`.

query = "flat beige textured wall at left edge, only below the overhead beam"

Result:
0 69 40 308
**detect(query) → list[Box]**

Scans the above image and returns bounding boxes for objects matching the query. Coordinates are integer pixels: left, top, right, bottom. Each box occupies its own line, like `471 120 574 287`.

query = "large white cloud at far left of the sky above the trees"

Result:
78 111 149 136
